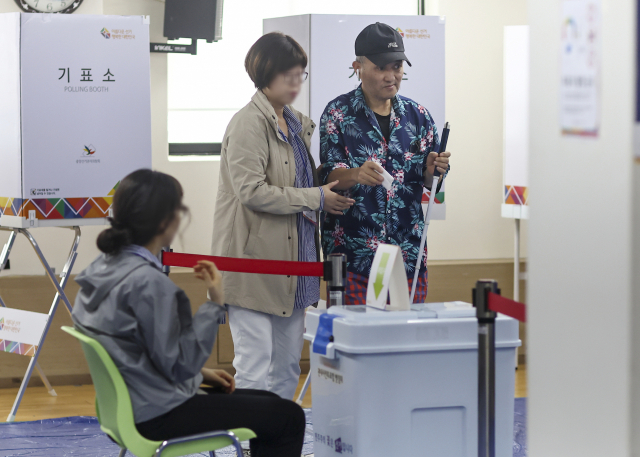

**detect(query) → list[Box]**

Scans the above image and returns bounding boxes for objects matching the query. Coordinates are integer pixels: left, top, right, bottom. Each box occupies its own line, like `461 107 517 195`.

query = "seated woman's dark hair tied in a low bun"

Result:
98 169 188 254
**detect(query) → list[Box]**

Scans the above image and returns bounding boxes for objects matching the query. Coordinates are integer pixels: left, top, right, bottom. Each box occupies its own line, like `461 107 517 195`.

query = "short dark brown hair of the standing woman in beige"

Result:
244 32 307 89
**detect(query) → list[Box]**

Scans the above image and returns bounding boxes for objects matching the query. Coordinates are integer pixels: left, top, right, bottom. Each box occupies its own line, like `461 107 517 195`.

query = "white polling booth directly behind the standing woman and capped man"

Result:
263 14 446 219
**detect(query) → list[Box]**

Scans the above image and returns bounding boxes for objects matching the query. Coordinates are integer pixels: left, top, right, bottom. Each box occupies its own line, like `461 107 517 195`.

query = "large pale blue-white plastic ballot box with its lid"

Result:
305 302 520 457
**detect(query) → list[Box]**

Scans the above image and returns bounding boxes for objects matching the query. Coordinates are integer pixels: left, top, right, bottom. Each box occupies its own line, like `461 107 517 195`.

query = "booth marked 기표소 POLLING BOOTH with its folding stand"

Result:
0 13 151 421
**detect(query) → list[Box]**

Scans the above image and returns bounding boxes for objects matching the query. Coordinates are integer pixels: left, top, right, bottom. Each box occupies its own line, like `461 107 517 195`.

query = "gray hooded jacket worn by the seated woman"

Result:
72 253 225 423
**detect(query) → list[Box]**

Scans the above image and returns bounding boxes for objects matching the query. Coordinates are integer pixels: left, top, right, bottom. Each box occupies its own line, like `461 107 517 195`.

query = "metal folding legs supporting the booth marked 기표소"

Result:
0 226 80 422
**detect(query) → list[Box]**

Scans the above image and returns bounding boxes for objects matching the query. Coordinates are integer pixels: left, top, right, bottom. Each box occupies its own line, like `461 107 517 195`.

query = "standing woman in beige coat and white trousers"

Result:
212 32 354 399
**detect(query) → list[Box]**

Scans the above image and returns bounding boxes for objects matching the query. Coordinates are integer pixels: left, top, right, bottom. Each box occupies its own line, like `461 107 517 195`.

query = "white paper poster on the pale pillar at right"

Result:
560 0 602 137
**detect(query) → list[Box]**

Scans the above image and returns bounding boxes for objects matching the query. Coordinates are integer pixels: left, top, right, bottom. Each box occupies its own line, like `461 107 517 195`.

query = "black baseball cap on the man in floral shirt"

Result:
356 22 411 67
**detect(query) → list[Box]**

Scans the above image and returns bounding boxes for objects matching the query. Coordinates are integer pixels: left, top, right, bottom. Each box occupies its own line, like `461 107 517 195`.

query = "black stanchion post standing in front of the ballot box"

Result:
473 279 500 457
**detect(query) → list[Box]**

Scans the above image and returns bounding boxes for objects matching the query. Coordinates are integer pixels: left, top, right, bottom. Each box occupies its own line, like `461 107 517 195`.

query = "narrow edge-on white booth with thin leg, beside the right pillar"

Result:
502 25 529 300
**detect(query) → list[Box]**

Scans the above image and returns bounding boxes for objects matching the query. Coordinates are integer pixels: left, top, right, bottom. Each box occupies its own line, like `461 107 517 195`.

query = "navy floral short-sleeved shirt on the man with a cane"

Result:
320 86 440 278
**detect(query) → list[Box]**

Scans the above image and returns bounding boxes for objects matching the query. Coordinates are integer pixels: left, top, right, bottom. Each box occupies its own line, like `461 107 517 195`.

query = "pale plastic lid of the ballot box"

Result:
305 302 521 354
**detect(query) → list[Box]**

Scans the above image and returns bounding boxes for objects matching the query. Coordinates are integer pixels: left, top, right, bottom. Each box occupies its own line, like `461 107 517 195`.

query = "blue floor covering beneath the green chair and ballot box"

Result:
0 398 527 457
